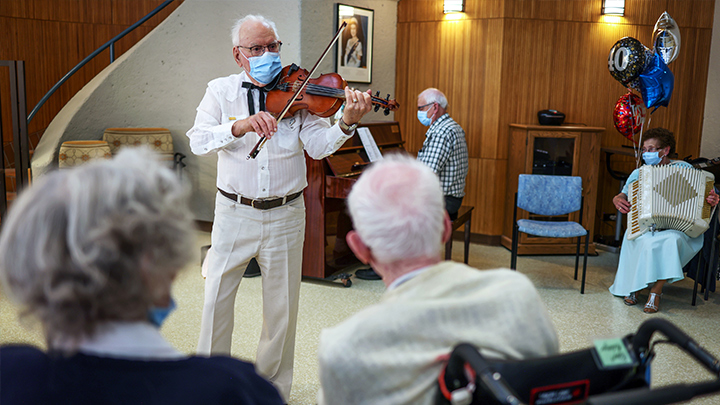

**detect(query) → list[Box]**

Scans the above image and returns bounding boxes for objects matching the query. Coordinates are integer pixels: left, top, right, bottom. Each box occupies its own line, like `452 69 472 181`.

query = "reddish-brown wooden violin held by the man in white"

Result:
265 63 399 118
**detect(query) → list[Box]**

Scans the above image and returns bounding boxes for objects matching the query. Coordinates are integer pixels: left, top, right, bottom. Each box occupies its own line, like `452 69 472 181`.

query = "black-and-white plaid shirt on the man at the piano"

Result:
418 114 468 198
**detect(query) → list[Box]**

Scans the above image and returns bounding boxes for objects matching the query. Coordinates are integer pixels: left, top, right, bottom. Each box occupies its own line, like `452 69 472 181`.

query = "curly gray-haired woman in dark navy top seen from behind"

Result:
0 149 282 405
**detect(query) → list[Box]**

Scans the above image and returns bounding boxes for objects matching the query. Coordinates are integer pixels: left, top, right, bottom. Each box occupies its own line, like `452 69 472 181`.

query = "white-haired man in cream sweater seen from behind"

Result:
318 156 558 404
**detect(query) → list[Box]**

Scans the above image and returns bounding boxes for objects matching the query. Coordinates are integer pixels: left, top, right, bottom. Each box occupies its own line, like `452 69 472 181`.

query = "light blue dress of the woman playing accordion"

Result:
610 160 703 297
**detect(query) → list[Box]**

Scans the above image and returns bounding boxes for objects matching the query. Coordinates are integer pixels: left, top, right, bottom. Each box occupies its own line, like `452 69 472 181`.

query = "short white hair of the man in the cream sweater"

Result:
348 154 445 263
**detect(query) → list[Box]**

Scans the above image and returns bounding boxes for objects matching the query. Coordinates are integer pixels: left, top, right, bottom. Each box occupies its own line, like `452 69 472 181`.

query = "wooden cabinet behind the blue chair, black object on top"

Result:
500 124 605 255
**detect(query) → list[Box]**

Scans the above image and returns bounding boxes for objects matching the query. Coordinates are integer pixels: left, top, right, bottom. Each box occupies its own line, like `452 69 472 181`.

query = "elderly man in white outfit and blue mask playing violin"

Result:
187 15 371 402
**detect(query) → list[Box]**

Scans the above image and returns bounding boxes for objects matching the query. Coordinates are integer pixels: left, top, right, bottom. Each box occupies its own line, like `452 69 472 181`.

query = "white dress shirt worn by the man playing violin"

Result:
187 72 352 199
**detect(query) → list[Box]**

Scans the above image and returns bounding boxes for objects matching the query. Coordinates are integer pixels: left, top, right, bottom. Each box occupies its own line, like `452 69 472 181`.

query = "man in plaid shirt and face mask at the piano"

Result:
417 87 468 220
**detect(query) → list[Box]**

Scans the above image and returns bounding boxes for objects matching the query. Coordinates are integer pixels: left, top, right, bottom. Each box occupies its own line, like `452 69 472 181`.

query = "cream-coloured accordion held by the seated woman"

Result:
627 165 715 240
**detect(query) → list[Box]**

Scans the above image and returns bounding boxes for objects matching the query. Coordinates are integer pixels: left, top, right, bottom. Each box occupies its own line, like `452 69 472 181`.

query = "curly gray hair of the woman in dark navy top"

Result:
0 148 195 347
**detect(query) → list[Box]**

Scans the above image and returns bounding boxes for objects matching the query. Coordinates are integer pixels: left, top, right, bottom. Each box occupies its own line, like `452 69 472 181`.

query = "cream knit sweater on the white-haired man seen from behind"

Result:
318 262 558 405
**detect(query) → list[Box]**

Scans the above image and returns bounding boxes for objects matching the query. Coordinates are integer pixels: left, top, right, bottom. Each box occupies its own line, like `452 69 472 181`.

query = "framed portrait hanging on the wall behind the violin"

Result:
335 4 375 83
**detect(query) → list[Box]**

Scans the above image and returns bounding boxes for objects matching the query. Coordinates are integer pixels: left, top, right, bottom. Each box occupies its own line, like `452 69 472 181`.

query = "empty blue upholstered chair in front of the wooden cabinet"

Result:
510 174 589 294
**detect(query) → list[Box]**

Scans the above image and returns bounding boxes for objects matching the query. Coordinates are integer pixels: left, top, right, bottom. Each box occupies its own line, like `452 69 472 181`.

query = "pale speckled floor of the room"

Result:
0 234 720 404
